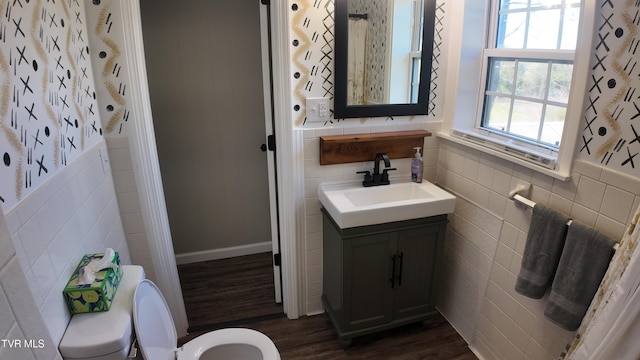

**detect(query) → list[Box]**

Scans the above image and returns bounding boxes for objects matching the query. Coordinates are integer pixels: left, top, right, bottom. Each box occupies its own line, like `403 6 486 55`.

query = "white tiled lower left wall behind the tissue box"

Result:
0 141 131 359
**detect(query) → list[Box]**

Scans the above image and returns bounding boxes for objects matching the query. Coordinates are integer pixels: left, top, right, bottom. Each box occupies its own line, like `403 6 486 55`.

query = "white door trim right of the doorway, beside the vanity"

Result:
266 0 306 319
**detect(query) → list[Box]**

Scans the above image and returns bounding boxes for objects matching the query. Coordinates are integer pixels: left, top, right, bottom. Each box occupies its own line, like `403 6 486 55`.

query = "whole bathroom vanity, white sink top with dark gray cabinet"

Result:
318 179 456 346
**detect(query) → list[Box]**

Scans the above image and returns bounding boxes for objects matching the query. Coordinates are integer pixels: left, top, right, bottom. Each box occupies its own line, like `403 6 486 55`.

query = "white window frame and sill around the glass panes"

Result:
439 0 596 180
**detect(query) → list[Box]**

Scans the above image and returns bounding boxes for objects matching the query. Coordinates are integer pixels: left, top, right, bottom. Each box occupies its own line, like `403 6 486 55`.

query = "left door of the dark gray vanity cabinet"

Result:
343 233 397 330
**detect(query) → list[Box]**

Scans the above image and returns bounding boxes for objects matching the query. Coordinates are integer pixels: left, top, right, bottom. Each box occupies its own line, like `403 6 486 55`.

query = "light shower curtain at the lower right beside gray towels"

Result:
561 207 640 360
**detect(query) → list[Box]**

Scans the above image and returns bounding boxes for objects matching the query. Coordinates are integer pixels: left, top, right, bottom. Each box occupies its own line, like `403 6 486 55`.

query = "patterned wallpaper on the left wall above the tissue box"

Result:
0 0 103 212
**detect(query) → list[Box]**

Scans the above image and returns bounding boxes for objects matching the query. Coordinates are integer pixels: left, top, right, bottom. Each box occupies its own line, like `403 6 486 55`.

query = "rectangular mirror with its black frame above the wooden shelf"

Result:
334 0 436 119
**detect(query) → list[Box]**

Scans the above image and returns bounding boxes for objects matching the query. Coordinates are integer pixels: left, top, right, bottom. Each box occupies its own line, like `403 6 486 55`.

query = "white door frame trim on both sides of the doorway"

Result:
119 0 304 330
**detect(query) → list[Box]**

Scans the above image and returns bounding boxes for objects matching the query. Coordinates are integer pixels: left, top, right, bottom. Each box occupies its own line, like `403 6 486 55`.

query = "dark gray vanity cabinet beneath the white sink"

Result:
322 209 447 346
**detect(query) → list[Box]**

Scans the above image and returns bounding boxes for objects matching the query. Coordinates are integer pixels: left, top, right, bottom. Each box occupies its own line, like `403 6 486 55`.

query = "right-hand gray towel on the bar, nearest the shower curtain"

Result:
544 221 615 331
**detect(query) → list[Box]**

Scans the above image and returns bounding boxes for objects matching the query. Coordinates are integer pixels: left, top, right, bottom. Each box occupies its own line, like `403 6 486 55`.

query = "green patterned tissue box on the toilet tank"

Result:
62 251 122 314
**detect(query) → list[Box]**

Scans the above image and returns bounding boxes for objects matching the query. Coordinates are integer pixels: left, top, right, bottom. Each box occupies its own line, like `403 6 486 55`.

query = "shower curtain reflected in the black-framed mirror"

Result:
347 19 368 105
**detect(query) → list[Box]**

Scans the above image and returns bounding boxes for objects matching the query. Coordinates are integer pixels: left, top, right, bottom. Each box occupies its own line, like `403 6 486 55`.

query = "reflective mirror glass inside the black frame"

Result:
347 0 424 105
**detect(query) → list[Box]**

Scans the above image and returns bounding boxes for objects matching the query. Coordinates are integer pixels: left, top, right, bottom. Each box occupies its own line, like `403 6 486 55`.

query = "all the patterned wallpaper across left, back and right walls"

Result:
0 0 640 212
